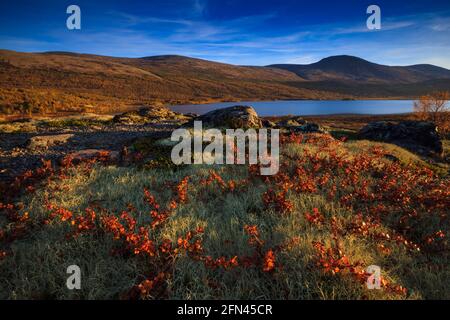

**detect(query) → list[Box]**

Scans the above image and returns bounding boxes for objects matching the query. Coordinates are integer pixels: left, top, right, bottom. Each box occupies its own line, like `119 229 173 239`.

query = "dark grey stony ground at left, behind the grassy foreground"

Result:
0 123 177 182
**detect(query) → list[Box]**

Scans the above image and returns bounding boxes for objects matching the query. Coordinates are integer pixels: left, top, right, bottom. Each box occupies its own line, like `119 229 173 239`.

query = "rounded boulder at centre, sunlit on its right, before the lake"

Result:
191 106 263 129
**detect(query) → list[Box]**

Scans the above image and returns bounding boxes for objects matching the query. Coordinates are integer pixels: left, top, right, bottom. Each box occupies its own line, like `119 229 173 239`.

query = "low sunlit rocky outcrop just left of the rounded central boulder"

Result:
113 106 192 124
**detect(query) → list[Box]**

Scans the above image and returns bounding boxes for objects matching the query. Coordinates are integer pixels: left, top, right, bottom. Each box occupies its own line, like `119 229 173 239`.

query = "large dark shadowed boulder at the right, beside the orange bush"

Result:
358 121 443 154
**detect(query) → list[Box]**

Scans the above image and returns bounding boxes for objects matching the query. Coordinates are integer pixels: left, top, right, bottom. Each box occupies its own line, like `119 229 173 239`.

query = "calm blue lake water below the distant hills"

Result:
170 100 413 116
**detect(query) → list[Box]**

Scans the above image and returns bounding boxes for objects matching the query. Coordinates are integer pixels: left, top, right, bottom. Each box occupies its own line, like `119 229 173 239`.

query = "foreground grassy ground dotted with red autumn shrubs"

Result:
0 136 450 299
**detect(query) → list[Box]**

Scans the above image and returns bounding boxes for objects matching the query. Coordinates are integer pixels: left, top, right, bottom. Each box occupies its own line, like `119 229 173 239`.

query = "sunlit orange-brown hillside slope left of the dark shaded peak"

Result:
0 50 338 113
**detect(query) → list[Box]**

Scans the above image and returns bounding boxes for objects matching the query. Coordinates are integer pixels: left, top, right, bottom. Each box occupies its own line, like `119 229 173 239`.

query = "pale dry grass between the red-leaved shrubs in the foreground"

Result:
0 136 450 299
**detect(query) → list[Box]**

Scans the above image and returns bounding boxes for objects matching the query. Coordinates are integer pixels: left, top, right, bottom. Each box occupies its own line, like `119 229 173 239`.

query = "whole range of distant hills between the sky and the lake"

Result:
0 50 450 113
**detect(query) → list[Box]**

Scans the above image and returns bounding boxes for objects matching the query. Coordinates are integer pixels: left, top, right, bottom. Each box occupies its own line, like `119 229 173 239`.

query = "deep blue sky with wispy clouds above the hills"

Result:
0 0 450 68
